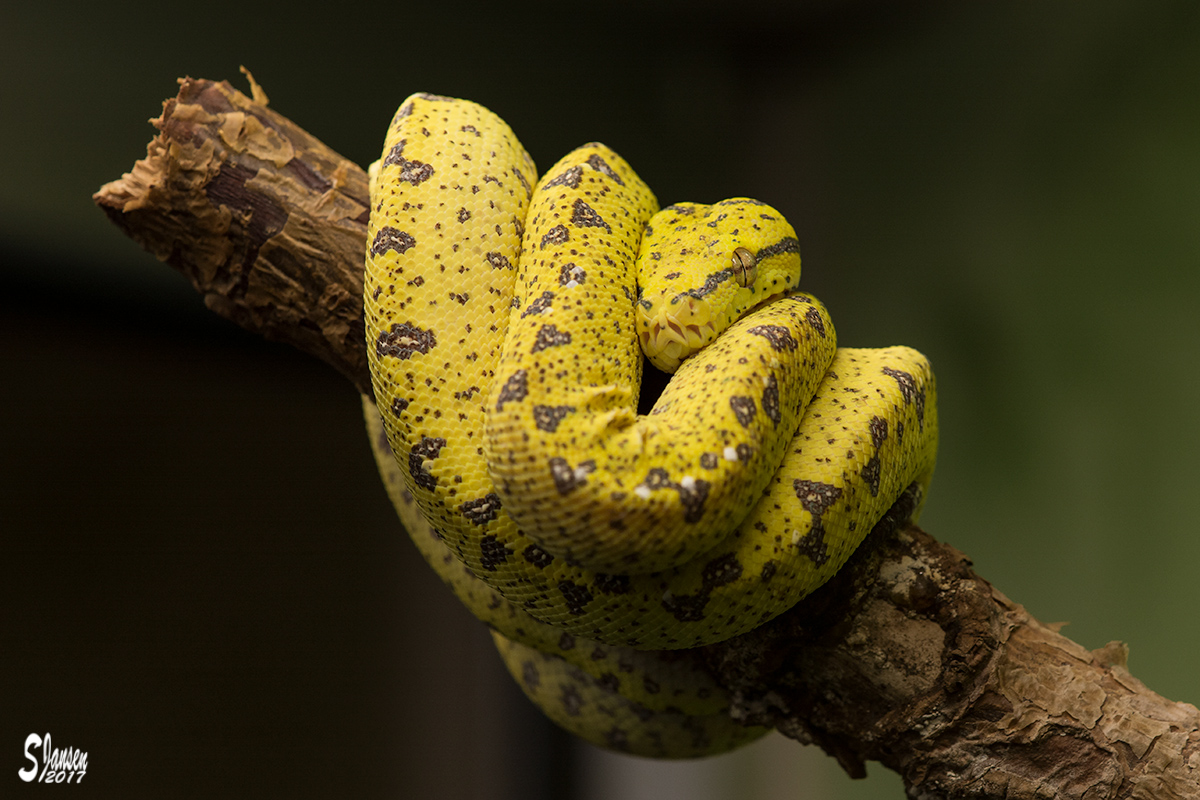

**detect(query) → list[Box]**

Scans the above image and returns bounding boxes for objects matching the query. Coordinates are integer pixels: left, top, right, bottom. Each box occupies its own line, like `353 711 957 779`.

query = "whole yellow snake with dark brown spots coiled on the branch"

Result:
364 94 937 758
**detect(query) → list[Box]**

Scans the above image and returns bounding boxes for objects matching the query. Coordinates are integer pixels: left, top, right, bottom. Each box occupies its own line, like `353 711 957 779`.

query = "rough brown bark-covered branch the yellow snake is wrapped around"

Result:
94 79 1200 800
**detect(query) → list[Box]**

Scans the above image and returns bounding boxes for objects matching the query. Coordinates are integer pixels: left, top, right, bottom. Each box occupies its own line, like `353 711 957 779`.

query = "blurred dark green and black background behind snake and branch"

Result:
0 0 1200 800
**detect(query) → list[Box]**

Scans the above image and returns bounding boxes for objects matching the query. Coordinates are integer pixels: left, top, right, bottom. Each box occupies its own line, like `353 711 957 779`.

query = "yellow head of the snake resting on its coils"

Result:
636 198 800 372
